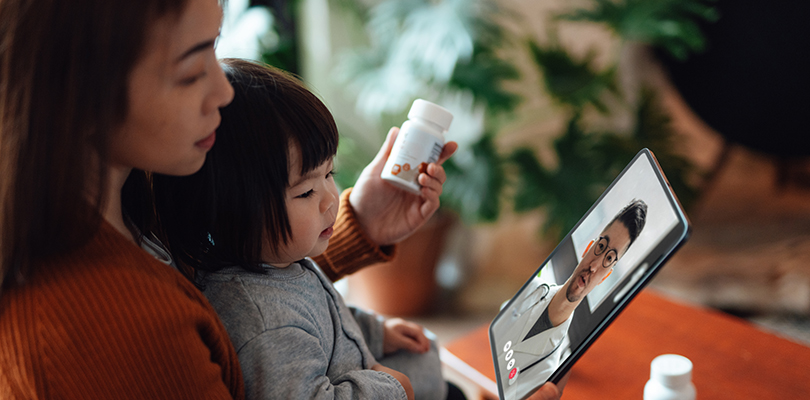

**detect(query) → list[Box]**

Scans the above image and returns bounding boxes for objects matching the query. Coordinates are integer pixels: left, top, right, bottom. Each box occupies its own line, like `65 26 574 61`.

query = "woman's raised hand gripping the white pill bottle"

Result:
349 128 458 246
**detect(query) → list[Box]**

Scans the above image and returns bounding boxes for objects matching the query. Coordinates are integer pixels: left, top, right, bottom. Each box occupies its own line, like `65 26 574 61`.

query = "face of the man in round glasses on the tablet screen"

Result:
565 221 630 303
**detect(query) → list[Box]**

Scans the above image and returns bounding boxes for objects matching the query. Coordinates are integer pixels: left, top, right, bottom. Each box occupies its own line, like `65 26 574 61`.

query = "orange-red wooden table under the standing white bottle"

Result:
443 290 810 400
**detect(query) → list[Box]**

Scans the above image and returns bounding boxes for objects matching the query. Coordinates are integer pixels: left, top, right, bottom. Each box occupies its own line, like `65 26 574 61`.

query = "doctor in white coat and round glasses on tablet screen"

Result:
498 200 647 400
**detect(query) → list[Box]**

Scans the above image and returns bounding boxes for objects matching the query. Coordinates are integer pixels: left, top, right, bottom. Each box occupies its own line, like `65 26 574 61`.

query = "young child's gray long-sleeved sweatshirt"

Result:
202 259 407 399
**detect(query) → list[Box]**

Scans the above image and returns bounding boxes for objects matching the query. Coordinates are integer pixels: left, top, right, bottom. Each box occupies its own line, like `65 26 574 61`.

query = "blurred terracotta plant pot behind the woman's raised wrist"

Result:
347 213 454 317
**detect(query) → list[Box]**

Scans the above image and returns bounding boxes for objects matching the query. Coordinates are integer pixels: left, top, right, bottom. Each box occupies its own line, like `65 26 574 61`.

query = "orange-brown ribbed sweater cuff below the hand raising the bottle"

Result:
313 188 396 282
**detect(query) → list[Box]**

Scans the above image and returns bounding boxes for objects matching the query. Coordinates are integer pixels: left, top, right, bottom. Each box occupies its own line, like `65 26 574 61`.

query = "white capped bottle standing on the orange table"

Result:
644 354 696 400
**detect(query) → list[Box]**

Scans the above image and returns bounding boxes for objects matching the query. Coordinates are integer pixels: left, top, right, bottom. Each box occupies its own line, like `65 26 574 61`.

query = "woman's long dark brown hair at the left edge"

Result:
0 0 187 286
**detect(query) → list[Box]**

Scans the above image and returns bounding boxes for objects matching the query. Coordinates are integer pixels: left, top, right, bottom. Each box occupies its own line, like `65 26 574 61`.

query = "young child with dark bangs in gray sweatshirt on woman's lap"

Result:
154 60 447 399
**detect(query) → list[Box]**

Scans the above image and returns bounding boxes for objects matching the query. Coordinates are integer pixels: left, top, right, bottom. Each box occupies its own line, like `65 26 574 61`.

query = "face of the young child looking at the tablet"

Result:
262 149 339 267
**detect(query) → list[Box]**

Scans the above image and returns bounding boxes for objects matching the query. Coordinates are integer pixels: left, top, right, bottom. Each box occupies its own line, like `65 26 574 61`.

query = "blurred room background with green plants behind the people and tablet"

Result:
217 0 810 345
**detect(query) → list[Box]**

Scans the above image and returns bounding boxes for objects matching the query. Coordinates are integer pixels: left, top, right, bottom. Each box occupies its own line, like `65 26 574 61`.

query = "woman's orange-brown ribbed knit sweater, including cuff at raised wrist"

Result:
0 192 391 399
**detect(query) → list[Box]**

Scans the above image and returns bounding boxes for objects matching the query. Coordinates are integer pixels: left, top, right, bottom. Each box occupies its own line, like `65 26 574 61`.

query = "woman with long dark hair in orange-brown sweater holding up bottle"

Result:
0 0 564 399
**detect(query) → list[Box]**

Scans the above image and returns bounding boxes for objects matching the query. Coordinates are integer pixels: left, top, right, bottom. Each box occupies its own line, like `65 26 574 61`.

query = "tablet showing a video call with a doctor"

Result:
489 149 690 400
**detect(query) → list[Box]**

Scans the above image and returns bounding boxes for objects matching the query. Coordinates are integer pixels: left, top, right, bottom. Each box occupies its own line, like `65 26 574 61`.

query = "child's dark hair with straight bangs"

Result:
153 59 338 272
